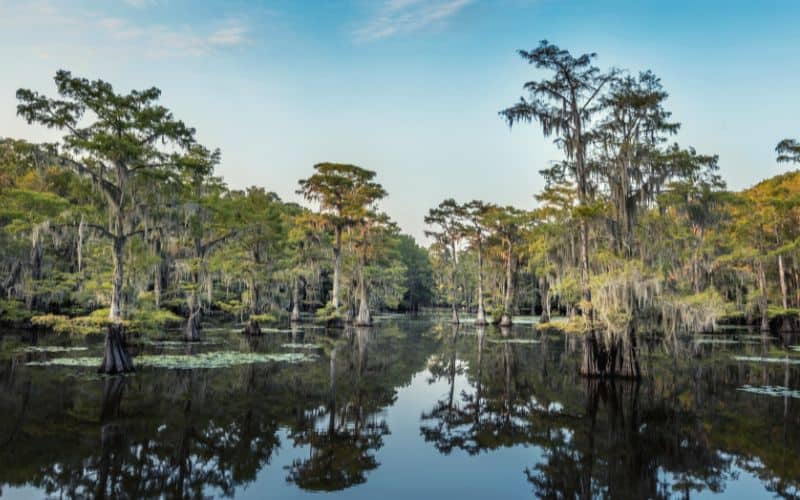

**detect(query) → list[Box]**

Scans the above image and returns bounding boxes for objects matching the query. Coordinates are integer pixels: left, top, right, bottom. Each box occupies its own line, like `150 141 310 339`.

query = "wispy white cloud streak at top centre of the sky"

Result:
354 0 473 42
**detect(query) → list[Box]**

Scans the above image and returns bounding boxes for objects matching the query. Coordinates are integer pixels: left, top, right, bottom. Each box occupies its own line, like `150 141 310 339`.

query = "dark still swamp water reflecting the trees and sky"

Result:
0 318 800 499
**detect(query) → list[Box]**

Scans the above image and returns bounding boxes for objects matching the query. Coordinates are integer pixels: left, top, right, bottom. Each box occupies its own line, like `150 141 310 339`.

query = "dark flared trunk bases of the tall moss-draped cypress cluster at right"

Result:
581 332 642 380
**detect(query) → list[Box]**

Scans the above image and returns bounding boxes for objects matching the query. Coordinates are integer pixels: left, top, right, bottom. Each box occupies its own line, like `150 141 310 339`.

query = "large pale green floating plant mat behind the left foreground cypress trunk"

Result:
27 351 316 370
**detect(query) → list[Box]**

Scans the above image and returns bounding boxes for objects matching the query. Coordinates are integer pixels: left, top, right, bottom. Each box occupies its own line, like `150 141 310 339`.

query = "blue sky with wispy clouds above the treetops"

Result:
0 0 800 239
